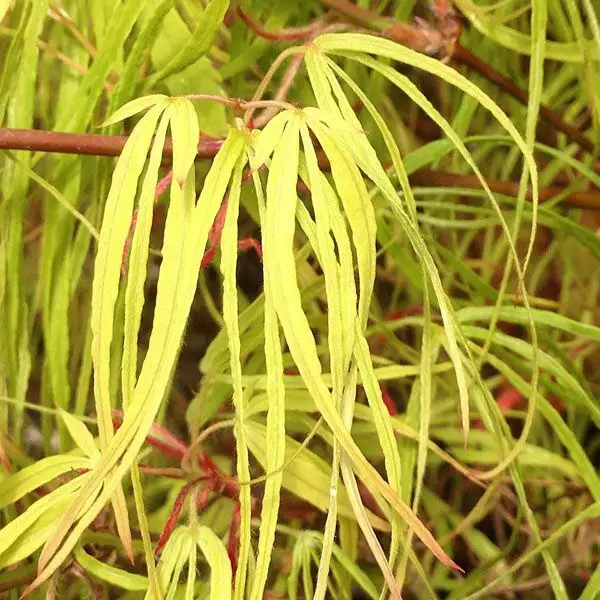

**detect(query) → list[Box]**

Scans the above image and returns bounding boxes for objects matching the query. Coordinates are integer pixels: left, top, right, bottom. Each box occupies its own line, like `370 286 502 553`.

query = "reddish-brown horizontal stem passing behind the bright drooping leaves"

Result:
0 128 600 209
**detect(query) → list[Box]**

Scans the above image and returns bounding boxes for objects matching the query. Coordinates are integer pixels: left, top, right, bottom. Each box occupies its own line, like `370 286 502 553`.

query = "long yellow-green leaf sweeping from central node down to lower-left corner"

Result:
29 130 244 589
